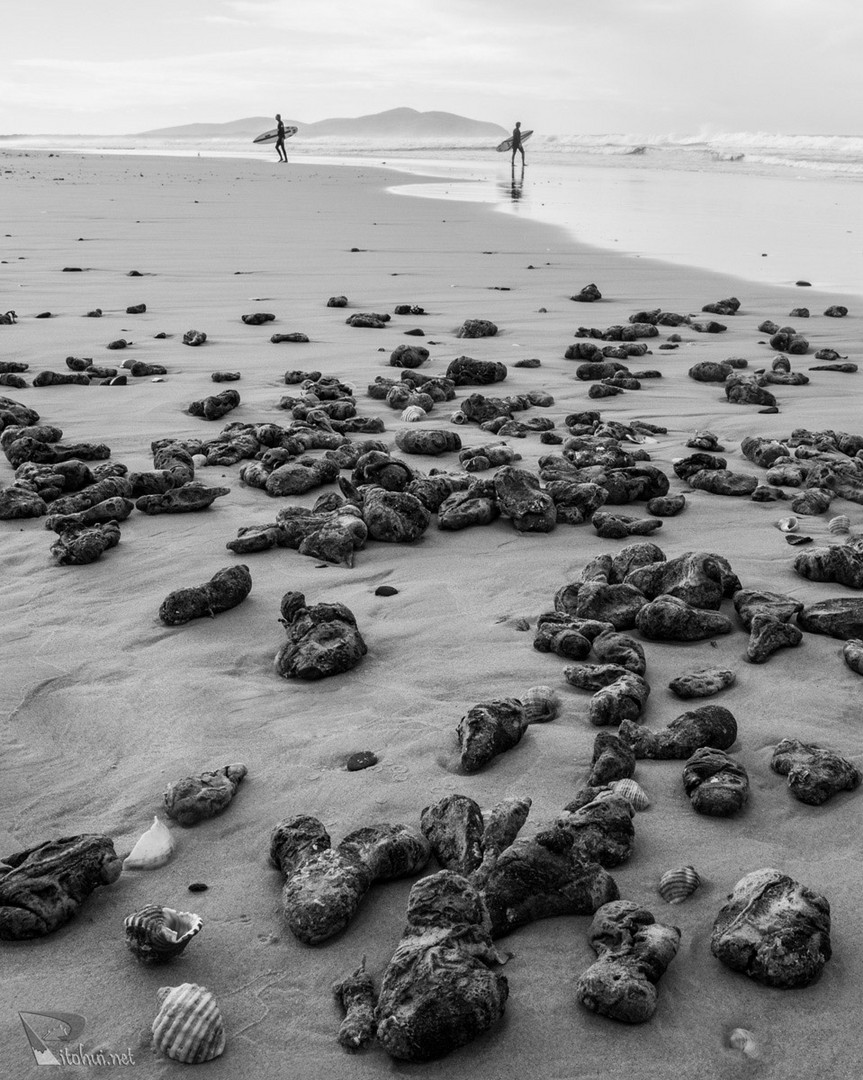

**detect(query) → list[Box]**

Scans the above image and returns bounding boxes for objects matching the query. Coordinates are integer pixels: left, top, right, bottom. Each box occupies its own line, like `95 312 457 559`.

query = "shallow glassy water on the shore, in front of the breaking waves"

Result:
0 146 863 298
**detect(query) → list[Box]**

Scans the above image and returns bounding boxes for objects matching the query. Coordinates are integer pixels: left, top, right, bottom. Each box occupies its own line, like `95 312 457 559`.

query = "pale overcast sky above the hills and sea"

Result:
0 0 863 135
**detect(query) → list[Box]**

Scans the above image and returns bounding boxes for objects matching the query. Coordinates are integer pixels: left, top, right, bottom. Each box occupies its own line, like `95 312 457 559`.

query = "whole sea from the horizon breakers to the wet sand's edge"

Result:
0 132 863 296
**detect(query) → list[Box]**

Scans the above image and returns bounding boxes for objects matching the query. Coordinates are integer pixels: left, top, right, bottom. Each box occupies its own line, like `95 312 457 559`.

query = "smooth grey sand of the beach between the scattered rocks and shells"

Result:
0 152 863 1080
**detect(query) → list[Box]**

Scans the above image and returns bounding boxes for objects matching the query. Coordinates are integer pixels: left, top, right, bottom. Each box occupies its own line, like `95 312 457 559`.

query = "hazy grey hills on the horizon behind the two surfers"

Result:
137 108 509 139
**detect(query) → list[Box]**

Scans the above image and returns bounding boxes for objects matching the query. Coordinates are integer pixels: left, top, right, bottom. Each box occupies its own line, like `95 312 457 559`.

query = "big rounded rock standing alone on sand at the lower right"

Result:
711 868 832 989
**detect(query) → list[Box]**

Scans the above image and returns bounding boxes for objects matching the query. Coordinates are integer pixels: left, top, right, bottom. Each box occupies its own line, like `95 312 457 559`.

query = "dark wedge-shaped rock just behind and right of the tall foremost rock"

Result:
482 826 620 937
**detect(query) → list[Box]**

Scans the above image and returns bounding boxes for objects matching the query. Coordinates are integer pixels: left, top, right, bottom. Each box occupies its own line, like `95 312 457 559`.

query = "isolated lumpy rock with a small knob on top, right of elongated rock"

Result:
275 592 368 679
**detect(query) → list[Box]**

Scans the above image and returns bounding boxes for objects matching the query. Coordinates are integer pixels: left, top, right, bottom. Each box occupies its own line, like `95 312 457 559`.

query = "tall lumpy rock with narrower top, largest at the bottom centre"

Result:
376 870 509 1062
